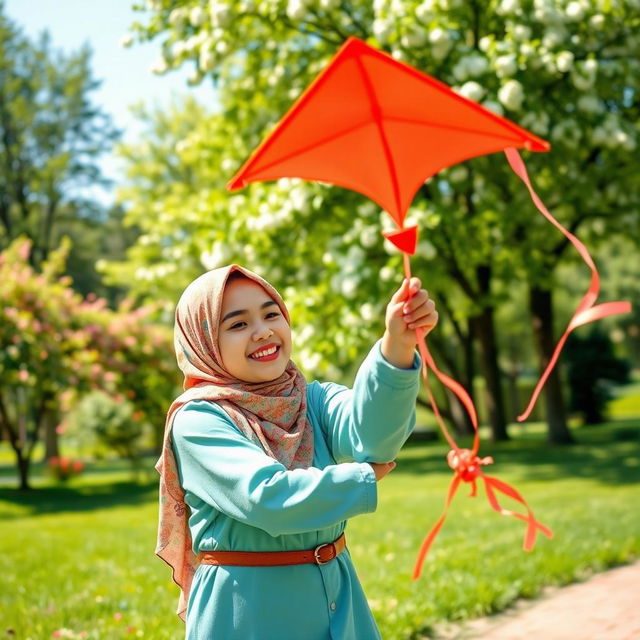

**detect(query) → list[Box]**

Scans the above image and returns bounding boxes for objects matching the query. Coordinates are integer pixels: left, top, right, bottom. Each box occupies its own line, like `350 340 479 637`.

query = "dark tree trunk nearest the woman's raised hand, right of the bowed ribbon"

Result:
473 307 509 442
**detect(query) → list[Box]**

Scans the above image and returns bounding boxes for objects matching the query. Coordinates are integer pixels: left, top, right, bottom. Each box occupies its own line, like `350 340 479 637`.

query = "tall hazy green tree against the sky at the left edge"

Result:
0 2 118 266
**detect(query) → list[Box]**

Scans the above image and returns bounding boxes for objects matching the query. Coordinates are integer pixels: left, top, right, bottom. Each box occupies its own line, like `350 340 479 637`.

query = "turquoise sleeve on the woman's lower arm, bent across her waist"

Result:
172 401 377 536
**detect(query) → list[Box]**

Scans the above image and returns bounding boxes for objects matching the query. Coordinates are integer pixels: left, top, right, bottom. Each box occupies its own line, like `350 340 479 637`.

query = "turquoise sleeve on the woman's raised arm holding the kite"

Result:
309 341 421 462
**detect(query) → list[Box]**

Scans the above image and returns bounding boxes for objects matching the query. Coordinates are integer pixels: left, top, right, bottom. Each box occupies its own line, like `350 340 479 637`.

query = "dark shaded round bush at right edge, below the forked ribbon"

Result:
566 328 630 424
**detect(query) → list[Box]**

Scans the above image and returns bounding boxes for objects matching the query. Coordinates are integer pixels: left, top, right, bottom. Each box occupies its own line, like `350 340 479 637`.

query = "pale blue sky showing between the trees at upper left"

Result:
0 0 215 202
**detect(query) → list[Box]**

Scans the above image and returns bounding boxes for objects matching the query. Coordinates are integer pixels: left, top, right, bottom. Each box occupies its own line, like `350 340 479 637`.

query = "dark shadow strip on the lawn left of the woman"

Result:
0 481 158 519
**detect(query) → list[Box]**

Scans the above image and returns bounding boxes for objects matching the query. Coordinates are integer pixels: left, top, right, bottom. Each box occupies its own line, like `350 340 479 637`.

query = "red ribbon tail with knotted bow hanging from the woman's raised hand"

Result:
404 253 553 580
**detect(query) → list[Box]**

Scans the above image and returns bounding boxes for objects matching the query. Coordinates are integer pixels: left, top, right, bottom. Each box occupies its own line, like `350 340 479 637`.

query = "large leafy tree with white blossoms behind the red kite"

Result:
116 0 640 441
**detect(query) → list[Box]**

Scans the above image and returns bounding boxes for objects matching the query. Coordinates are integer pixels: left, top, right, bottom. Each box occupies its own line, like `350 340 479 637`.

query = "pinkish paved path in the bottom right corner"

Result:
436 562 640 640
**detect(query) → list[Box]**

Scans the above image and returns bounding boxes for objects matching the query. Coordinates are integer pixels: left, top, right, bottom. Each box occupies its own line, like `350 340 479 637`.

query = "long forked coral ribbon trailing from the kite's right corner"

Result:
504 147 631 422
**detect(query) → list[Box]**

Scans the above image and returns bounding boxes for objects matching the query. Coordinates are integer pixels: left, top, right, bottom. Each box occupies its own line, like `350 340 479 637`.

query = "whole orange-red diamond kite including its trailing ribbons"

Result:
228 38 630 578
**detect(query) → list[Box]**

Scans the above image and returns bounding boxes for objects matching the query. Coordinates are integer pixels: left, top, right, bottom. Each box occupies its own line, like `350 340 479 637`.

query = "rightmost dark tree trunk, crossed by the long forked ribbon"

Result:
529 286 575 444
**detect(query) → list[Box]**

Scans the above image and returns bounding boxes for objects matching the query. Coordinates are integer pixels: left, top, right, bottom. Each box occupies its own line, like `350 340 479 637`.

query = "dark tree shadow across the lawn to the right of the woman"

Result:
396 419 640 485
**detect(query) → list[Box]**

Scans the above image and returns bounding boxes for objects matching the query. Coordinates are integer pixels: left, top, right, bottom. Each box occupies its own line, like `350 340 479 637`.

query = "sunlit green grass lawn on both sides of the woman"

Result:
0 419 640 640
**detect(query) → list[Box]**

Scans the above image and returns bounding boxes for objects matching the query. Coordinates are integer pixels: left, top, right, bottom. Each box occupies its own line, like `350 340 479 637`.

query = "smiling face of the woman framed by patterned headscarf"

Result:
218 277 291 382
